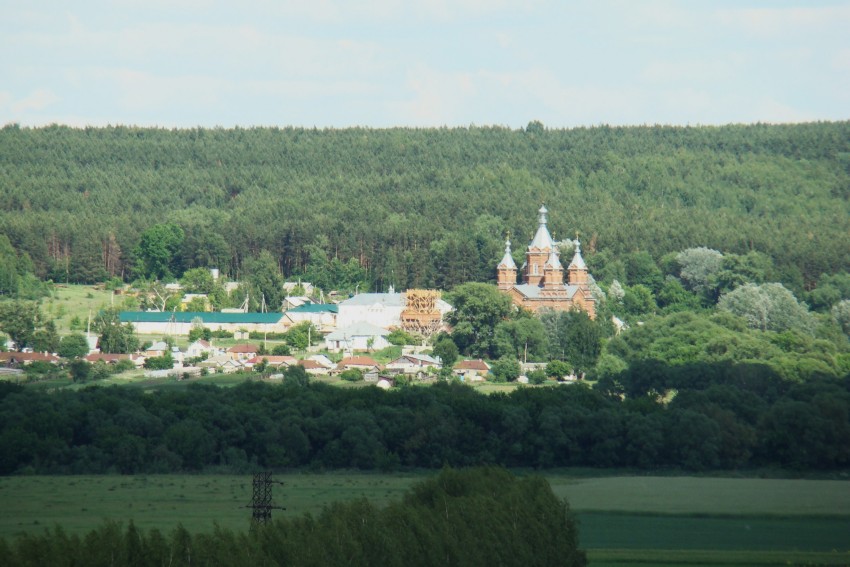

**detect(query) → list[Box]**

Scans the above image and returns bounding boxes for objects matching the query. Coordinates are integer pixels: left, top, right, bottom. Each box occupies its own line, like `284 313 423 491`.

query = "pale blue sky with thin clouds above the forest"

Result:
0 0 850 128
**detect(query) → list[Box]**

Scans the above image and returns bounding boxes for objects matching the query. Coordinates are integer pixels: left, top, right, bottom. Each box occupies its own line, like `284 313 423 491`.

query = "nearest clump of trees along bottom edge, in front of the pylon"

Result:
0 468 587 567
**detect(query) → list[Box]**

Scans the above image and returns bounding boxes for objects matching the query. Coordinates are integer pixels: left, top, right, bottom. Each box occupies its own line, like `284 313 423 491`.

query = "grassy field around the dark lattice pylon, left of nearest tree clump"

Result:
0 473 422 537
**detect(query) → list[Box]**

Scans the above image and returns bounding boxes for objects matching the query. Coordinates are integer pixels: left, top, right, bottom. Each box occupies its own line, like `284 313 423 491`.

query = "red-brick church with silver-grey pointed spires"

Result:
496 206 596 319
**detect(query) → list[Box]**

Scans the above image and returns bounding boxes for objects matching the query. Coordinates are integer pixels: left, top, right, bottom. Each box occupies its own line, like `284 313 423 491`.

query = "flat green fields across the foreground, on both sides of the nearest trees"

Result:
0 473 850 565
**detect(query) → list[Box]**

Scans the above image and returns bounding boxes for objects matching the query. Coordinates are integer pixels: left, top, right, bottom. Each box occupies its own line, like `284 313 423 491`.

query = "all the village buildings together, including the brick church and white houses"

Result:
0 206 596 379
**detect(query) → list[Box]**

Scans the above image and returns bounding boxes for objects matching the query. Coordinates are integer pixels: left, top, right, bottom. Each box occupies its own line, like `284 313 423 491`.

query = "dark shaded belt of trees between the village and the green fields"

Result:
0 363 850 474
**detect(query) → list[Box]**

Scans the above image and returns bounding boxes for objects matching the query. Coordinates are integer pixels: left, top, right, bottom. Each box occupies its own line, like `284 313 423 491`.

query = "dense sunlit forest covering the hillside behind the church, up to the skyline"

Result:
0 122 850 296
